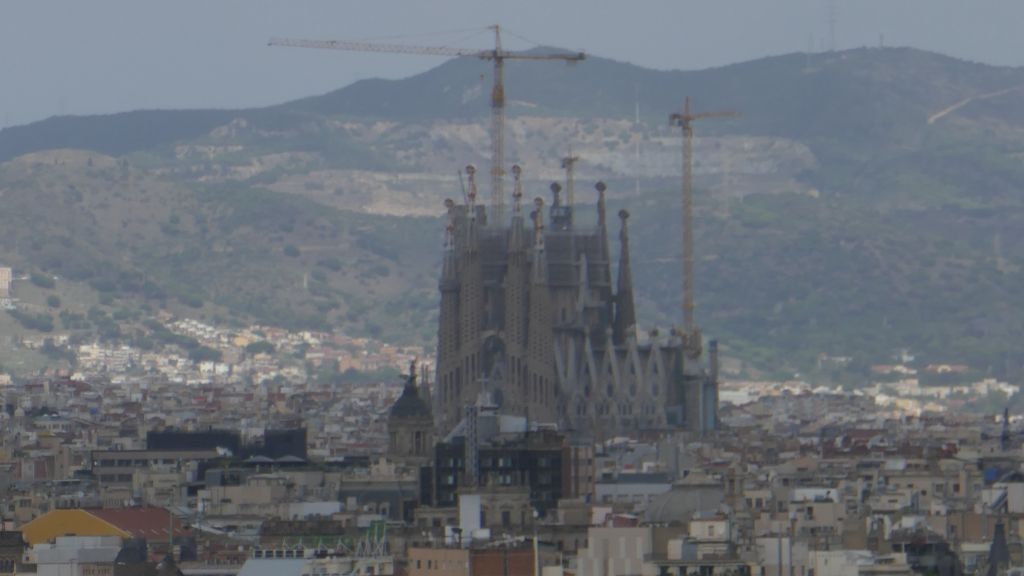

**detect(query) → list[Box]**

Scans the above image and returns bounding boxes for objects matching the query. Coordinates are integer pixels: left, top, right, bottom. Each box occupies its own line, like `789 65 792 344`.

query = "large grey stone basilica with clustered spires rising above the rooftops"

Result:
433 166 718 436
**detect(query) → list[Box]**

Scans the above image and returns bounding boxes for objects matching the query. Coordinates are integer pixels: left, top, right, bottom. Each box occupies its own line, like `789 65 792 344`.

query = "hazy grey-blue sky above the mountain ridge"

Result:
0 0 1024 126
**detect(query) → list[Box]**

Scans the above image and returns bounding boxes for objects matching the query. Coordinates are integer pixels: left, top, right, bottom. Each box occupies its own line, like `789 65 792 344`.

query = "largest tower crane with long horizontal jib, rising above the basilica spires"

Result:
269 25 587 225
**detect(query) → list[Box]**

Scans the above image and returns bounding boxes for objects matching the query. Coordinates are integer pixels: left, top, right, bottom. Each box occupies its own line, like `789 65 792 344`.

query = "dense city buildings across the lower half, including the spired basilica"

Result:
0 169 1024 576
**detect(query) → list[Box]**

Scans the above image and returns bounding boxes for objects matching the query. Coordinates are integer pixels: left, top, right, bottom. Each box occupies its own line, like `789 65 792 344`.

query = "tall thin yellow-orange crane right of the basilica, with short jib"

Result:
669 96 739 347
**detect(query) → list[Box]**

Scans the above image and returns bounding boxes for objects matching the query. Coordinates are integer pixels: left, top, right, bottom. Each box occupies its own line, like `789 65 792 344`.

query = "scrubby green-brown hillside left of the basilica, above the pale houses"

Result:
0 152 439 341
